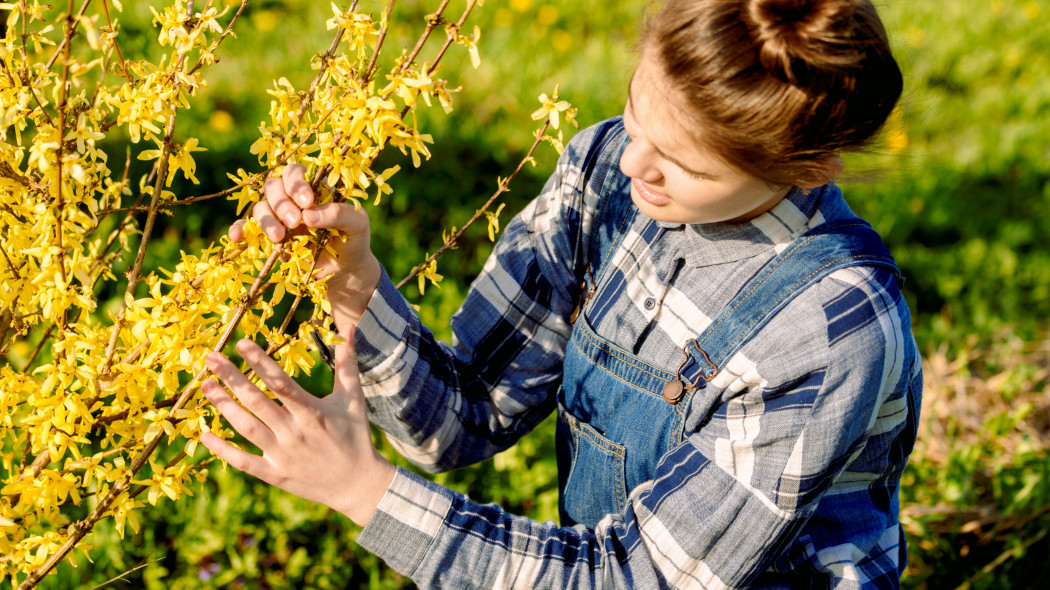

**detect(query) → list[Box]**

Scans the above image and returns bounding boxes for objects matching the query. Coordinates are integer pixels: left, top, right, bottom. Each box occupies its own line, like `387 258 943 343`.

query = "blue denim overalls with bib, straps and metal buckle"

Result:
557 133 901 528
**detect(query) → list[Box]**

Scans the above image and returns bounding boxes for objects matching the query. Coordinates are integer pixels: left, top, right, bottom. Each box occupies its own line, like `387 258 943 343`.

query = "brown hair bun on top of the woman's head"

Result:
747 0 866 86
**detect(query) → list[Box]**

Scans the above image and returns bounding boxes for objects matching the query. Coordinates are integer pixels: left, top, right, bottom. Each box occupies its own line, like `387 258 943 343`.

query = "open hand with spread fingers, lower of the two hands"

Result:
201 338 395 526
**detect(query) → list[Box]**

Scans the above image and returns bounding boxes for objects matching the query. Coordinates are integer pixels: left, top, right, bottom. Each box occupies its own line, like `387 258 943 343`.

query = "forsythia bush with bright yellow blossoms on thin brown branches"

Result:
0 0 574 588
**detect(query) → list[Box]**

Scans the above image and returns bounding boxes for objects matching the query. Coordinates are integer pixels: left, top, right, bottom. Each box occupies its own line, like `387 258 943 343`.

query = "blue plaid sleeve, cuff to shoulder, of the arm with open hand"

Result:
358 264 922 589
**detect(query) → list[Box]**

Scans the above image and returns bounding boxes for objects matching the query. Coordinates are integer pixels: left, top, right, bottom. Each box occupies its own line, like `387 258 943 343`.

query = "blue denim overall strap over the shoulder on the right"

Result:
672 218 903 387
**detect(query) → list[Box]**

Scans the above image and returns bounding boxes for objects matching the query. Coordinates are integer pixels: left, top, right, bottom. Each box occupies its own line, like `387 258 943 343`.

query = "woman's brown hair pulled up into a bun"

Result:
642 0 903 185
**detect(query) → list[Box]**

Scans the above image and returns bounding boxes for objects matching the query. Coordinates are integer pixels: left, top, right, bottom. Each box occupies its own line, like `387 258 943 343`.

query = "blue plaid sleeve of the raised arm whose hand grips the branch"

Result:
355 121 609 471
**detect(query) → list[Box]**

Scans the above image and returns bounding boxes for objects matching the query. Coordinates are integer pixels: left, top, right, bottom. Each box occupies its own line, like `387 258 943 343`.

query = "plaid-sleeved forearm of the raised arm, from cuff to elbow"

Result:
355 268 561 471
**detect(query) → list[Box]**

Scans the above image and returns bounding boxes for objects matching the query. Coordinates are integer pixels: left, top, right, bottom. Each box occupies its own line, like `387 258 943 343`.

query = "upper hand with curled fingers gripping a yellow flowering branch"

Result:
228 164 382 332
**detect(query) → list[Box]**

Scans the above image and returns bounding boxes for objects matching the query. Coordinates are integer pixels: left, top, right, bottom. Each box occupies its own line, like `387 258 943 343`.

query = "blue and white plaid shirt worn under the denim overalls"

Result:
356 118 922 589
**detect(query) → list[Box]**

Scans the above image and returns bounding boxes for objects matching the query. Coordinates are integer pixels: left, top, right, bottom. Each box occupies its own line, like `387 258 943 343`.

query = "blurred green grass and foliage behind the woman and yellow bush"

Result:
24 0 1050 590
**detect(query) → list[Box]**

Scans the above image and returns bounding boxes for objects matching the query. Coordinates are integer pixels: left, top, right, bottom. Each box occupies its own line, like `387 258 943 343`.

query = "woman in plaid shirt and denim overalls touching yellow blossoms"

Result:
202 0 922 588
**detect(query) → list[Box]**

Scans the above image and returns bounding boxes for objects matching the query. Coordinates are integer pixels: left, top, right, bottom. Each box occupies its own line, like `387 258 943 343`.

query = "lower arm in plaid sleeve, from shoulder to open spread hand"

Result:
202 248 921 589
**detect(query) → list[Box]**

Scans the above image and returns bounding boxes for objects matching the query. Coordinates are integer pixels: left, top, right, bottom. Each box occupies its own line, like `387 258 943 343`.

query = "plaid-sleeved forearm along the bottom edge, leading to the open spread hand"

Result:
358 443 799 590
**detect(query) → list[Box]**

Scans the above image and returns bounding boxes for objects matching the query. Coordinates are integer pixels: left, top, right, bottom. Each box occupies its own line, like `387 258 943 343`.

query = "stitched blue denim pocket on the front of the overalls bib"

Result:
558 401 627 528
